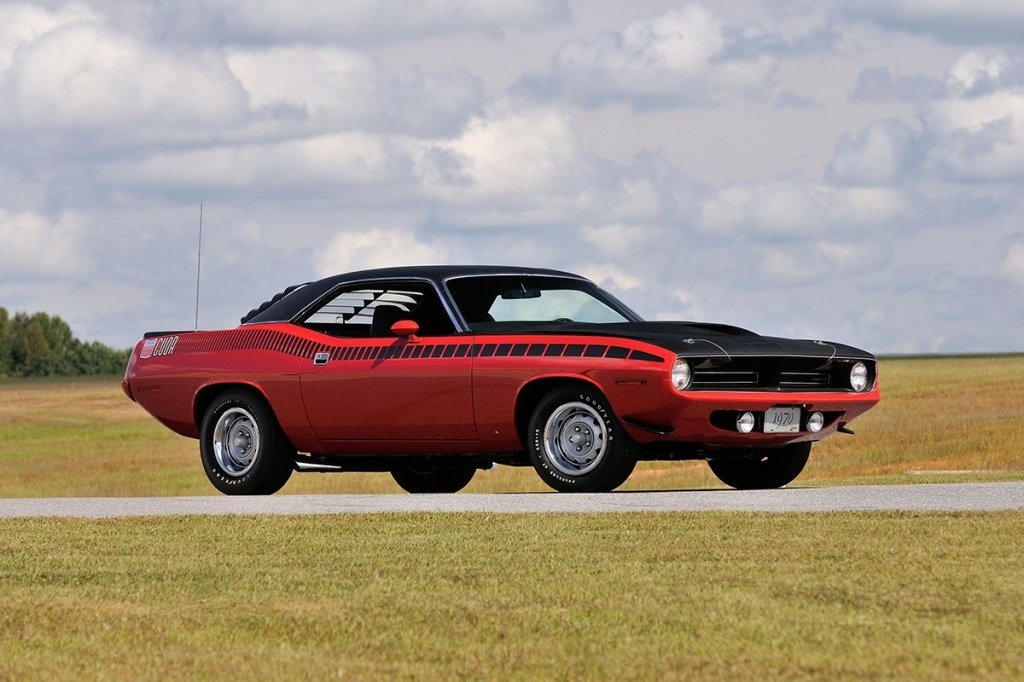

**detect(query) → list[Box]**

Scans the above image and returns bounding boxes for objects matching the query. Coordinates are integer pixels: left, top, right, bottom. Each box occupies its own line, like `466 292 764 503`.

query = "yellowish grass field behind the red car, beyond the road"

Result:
0 355 1024 497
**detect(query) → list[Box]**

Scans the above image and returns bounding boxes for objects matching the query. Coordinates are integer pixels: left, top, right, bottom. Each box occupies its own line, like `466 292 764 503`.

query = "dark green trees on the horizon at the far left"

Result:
0 307 131 379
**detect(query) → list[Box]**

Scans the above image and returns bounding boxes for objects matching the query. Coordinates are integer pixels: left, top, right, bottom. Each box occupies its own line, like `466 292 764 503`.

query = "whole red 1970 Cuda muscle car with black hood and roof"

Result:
123 266 880 495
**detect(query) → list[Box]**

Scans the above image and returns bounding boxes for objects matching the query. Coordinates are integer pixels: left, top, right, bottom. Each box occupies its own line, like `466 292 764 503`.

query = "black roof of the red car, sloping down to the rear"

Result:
242 265 583 324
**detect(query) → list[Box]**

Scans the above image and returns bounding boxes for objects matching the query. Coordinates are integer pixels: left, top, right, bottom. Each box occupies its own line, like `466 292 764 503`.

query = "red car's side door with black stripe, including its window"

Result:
292 281 477 444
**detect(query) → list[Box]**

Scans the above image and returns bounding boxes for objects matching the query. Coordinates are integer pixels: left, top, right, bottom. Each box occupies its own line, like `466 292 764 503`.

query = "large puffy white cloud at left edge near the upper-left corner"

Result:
0 12 246 138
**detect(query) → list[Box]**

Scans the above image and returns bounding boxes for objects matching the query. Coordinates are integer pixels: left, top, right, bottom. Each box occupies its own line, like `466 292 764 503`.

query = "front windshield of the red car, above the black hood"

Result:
446 275 639 331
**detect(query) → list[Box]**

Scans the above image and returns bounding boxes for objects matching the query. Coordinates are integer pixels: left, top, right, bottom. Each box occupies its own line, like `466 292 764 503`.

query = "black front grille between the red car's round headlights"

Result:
687 357 873 391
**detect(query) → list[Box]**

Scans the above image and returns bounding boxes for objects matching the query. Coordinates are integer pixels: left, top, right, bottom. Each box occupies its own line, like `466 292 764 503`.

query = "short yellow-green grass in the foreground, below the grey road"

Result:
0 512 1024 680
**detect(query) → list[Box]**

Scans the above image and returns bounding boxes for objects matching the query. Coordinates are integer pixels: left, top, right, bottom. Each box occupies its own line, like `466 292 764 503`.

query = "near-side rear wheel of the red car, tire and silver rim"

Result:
200 390 295 495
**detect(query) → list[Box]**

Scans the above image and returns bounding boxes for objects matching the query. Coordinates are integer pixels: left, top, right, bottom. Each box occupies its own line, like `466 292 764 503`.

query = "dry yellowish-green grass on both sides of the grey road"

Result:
0 356 1024 680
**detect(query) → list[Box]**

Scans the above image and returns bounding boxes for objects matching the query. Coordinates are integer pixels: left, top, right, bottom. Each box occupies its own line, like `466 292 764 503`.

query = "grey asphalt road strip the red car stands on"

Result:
0 482 1024 518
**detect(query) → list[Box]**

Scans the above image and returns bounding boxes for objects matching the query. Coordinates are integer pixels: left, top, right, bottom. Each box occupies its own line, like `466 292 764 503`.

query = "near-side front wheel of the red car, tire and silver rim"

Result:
526 385 636 493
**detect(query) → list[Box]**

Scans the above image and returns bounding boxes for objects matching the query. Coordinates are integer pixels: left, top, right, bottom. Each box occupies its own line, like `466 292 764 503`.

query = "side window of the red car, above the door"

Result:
303 282 455 337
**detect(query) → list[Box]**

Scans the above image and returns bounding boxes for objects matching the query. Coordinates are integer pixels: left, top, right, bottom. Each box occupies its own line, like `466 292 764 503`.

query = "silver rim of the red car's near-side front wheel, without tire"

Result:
544 402 608 476
